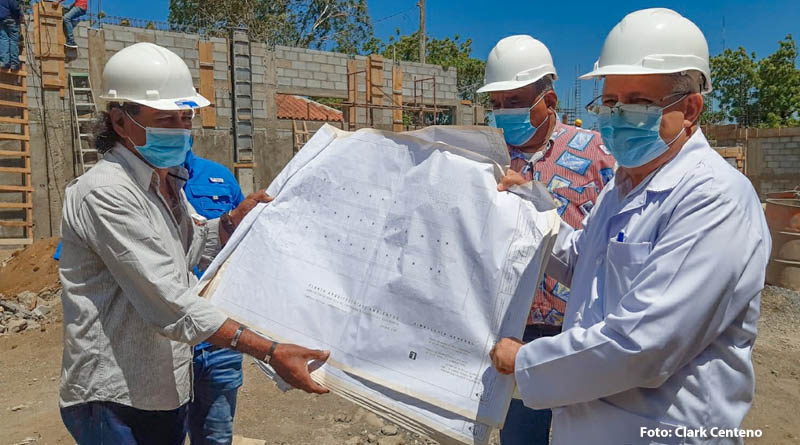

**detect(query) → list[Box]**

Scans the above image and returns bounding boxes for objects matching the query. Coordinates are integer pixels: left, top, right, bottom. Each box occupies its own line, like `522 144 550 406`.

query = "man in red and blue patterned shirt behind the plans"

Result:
478 35 614 445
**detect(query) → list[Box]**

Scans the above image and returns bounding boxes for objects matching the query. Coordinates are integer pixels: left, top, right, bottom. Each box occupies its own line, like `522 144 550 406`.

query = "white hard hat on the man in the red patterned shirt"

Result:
478 35 558 93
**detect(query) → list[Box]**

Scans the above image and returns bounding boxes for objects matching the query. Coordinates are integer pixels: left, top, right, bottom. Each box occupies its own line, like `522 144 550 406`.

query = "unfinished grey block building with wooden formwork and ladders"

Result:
0 2 483 245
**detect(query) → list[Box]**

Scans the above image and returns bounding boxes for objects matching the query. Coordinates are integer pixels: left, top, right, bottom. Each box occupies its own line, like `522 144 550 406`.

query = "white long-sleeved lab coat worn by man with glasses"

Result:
515 129 771 445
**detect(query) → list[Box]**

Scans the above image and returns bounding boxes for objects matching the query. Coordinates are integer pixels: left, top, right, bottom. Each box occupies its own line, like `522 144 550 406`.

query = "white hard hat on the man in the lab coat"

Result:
580 8 711 93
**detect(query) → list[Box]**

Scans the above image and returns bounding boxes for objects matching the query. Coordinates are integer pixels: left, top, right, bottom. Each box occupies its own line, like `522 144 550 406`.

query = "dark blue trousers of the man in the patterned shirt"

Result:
500 326 559 445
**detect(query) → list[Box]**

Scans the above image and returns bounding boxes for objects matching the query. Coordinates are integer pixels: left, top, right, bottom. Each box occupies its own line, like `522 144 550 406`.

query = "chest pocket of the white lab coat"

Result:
603 239 652 315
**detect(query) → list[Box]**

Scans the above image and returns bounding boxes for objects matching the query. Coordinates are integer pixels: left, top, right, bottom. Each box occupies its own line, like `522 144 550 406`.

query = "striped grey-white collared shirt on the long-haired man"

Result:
59 145 226 410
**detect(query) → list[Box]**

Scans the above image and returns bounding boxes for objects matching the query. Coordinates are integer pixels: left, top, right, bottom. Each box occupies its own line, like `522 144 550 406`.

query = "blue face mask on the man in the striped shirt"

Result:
125 112 193 168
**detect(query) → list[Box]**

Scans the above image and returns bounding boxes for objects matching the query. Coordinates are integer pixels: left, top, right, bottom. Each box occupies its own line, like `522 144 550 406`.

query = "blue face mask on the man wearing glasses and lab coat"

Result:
597 96 686 168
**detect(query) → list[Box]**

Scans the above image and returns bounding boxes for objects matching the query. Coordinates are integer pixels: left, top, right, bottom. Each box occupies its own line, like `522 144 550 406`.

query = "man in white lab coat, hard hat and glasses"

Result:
491 8 771 444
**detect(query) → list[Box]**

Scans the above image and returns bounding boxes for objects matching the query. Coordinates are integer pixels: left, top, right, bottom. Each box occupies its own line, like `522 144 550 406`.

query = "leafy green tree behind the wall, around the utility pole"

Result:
362 29 486 102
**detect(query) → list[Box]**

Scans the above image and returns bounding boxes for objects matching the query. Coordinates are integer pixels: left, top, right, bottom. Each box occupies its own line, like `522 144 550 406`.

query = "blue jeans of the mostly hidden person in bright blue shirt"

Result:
187 343 242 445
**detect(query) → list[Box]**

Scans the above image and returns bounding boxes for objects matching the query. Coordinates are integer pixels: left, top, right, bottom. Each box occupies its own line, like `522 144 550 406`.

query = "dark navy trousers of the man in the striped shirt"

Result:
61 402 188 445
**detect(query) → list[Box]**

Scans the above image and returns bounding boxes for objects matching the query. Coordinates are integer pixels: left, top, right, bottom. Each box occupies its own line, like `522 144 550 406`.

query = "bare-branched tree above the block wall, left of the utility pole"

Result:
169 0 372 54
